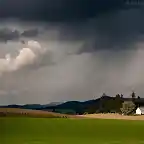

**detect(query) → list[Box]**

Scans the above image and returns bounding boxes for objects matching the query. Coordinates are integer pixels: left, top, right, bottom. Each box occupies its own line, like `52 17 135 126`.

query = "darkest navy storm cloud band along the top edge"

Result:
0 0 125 21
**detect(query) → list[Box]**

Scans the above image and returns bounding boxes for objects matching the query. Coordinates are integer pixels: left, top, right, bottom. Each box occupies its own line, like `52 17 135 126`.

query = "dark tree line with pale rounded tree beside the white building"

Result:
86 92 140 115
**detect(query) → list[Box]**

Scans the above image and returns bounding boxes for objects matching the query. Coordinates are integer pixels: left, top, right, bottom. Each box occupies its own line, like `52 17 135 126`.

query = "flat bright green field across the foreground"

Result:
0 118 144 144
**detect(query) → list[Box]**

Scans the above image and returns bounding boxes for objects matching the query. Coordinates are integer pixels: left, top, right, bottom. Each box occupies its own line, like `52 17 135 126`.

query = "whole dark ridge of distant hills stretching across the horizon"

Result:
1 96 144 115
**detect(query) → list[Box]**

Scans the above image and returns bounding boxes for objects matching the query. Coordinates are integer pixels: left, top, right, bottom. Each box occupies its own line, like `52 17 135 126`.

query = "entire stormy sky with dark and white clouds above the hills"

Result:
0 0 144 105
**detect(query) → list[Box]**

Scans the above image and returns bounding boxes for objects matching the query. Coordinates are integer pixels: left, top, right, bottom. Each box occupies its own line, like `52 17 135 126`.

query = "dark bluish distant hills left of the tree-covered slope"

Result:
0 99 100 114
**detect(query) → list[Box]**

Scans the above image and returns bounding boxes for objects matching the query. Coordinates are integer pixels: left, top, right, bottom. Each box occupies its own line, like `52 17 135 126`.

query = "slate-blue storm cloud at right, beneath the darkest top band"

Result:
76 9 144 52
